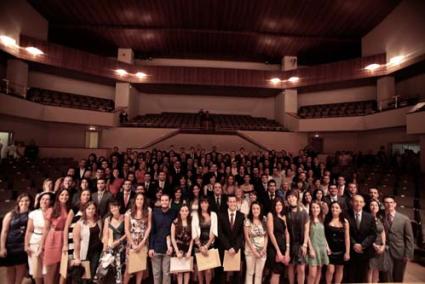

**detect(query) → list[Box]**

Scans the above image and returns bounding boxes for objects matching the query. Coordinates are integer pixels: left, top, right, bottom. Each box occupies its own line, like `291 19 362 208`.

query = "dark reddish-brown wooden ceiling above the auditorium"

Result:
28 0 400 65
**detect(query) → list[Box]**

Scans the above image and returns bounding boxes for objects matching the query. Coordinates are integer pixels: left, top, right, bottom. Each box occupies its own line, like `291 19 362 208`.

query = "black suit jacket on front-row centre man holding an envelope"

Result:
218 210 245 252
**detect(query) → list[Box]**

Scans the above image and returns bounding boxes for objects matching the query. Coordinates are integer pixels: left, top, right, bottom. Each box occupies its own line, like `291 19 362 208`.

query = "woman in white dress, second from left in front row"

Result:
25 192 54 284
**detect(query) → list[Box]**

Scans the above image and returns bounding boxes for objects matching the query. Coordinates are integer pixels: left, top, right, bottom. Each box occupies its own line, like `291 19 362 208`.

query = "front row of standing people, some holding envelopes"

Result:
0 189 413 284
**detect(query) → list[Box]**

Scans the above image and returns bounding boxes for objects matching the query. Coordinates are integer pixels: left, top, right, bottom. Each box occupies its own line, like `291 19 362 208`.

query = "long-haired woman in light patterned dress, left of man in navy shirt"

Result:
124 193 152 284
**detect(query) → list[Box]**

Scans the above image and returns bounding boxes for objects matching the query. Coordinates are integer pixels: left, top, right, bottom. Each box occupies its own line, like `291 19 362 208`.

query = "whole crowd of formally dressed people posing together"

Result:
0 148 414 284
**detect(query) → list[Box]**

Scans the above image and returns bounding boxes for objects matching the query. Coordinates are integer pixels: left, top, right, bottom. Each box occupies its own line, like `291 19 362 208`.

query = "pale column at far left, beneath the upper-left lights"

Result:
6 59 28 97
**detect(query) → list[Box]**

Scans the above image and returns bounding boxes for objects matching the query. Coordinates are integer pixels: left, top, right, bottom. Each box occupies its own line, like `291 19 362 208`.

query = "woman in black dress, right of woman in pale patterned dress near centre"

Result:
267 197 289 284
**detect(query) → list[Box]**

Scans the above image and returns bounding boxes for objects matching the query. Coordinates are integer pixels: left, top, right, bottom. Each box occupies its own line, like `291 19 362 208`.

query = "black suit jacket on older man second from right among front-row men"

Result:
347 210 376 259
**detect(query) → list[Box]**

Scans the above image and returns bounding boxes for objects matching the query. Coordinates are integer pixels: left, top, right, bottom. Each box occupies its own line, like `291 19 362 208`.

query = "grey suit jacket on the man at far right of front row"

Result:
384 212 414 259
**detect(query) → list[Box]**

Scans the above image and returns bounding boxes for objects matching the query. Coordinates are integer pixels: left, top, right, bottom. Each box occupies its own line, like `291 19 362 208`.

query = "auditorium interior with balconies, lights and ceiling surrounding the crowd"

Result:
0 0 425 283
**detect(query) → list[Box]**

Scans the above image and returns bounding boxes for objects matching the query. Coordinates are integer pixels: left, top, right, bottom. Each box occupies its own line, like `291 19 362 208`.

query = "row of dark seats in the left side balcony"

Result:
27 88 115 112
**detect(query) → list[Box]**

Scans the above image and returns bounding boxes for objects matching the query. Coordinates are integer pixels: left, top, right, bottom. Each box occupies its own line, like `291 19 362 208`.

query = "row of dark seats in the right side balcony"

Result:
298 101 377 118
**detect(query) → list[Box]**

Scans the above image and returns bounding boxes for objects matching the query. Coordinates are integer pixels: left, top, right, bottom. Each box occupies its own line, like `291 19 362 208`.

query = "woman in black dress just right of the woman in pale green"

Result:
325 201 350 284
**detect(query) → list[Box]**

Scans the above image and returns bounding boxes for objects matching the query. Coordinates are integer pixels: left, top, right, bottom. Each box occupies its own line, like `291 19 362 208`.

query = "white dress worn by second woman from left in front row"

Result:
28 209 46 277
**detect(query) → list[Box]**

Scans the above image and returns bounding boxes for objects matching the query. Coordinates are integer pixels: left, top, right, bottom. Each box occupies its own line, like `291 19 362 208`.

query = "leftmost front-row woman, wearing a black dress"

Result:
0 193 31 283
